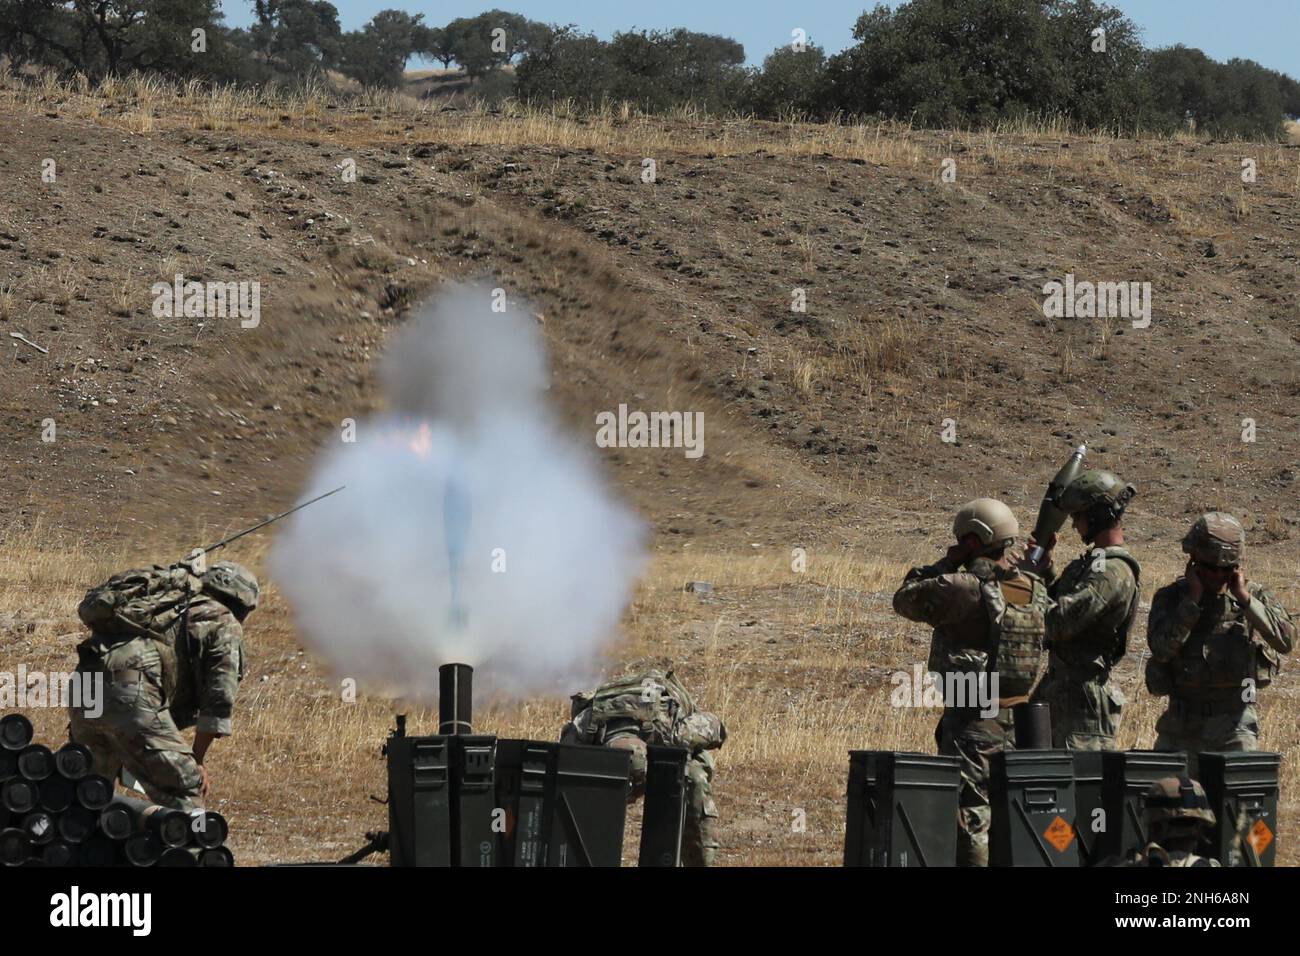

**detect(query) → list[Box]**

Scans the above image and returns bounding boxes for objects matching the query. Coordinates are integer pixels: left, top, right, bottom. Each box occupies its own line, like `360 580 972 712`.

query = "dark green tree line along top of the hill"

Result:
0 0 1300 137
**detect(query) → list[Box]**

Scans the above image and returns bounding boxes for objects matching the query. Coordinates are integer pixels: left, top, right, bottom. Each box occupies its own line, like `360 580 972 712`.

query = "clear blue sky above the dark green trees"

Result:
222 0 1300 79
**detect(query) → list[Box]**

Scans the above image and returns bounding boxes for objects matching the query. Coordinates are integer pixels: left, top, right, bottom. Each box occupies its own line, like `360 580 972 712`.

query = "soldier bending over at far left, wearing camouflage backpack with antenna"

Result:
70 562 260 810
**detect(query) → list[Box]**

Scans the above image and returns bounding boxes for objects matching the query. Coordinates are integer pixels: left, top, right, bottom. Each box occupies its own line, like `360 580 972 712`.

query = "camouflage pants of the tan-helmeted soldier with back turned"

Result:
935 708 1015 866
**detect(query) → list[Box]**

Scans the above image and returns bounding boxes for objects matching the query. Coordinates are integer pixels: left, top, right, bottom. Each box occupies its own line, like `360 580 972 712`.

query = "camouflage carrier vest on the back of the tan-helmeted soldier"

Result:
980 572 1052 697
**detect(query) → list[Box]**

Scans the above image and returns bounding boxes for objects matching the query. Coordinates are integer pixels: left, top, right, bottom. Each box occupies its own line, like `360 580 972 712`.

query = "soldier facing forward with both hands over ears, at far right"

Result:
1147 511 1296 774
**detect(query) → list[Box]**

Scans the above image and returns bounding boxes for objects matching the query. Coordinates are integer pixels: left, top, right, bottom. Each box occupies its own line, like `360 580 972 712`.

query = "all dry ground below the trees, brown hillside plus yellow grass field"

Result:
0 72 1300 865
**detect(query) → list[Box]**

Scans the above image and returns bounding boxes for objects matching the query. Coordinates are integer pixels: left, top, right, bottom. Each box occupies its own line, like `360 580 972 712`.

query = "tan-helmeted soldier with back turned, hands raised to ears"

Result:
893 498 1045 866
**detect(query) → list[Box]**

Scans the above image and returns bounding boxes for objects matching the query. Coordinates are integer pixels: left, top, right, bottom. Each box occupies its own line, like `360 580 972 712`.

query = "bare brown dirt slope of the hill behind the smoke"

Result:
0 100 1300 556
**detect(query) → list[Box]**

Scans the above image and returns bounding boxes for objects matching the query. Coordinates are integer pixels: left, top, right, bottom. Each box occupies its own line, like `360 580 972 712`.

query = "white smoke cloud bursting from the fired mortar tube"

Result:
270 286 644 701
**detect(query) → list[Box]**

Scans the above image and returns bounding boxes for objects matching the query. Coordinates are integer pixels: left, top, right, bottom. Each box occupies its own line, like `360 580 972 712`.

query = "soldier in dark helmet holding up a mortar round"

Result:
1024 471 1141 750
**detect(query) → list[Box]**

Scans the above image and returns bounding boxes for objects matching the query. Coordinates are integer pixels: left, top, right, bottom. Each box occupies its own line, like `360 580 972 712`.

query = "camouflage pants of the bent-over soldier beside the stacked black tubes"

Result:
69 672 202 810
